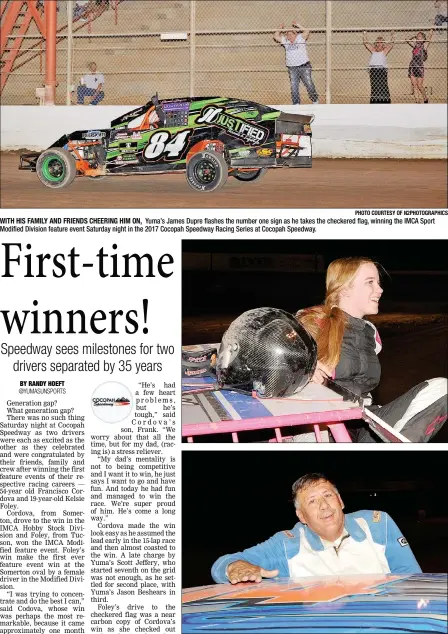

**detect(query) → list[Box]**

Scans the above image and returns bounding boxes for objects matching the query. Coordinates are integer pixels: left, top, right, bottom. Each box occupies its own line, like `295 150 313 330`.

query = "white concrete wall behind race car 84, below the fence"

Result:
1 104 447 159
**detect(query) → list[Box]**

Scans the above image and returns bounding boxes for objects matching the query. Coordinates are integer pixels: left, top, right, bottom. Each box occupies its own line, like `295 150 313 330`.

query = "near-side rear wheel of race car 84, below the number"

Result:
185 150 229 192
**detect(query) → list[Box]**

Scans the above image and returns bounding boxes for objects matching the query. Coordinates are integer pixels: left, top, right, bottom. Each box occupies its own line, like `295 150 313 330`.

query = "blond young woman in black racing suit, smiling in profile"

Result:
296 257 447 442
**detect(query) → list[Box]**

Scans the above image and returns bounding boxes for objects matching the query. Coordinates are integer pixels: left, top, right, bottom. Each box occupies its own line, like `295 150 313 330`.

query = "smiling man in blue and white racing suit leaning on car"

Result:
212 473 421 583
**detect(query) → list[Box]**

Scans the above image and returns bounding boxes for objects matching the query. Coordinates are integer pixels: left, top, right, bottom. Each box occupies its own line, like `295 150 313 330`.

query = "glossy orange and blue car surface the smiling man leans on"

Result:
182 573 447 634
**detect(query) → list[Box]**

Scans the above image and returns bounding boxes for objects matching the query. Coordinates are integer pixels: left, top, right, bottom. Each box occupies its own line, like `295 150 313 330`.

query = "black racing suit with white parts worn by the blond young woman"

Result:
333 315 447 442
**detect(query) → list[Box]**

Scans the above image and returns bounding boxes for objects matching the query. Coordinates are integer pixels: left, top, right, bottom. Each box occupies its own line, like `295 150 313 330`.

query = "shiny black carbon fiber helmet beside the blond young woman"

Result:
216 308 317 398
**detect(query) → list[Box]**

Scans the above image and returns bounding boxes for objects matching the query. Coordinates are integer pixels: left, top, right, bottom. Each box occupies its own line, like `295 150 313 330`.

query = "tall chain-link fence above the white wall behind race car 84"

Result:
2 0 447 104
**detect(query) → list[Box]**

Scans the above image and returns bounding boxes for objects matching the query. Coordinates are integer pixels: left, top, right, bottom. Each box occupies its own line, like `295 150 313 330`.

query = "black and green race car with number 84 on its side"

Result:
19 95 314 192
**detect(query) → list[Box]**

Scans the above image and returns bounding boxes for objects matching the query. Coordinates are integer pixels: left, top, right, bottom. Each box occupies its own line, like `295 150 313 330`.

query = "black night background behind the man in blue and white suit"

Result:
182 449 448 587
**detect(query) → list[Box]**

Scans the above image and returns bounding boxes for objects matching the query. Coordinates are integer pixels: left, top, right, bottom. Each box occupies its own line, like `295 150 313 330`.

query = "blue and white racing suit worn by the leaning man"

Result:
212 511 421 583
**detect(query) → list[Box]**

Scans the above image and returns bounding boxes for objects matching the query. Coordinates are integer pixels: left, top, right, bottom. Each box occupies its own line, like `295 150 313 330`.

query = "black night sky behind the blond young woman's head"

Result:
182 240 448 316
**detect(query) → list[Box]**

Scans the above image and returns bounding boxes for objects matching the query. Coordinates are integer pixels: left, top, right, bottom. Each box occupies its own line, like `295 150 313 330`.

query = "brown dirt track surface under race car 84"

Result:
1 152 447 209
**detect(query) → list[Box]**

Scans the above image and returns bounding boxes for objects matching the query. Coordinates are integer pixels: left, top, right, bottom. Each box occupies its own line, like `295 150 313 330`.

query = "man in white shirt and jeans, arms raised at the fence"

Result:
274 22 319 104
